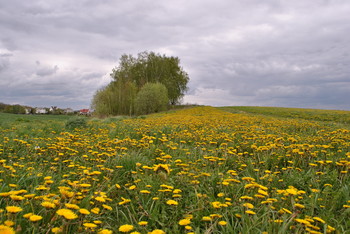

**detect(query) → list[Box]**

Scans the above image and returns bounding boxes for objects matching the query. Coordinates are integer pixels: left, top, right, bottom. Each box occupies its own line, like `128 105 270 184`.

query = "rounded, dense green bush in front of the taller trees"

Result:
135 83 169 115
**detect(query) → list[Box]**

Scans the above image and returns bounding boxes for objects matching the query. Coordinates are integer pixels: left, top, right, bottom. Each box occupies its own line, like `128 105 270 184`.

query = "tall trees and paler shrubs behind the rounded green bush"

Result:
91 52 189 116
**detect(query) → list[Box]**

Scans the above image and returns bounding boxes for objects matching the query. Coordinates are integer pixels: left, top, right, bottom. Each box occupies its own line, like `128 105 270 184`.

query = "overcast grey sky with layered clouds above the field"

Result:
0 0 350 110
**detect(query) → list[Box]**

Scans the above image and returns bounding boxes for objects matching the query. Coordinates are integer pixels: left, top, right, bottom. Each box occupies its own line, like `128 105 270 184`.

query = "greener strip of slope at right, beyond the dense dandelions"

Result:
220 106 350 126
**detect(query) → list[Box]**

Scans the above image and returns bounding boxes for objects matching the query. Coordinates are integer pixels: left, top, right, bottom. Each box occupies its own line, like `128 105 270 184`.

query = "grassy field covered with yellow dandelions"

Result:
0 107 350 234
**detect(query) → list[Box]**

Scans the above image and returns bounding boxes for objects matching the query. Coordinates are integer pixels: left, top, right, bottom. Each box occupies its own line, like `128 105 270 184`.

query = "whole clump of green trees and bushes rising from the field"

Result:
91 51 189 116
